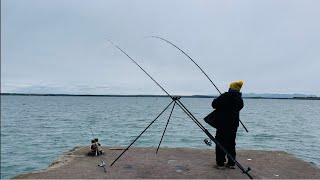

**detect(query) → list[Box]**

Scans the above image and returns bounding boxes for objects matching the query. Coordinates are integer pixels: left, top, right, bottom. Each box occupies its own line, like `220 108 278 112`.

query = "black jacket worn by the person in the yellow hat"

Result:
211 90 243 131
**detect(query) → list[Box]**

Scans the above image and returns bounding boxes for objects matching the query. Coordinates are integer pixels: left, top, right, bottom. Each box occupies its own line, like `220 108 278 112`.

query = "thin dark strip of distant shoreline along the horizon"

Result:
1 93 320 100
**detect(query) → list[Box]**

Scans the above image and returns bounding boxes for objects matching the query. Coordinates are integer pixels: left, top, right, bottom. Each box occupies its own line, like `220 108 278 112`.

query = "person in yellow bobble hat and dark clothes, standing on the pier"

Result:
211 81 244 169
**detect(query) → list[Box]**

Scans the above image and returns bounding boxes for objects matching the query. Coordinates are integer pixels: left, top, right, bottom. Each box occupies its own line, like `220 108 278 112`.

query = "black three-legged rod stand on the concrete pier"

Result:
110 96 252 179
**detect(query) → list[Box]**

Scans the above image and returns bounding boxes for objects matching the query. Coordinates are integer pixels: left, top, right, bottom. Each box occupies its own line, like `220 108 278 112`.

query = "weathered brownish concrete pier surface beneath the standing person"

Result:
14 146 320 179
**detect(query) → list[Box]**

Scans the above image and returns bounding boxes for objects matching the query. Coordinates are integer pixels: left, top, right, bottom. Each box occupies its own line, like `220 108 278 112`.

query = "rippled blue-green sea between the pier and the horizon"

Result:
1 95 320 179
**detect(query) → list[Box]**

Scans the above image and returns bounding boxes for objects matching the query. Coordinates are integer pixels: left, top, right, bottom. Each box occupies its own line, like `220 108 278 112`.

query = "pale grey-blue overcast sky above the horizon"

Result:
1 0 320 96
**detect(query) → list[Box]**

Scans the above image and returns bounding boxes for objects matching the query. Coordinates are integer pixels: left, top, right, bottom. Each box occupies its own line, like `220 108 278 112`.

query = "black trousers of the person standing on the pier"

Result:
216 130 237 166
